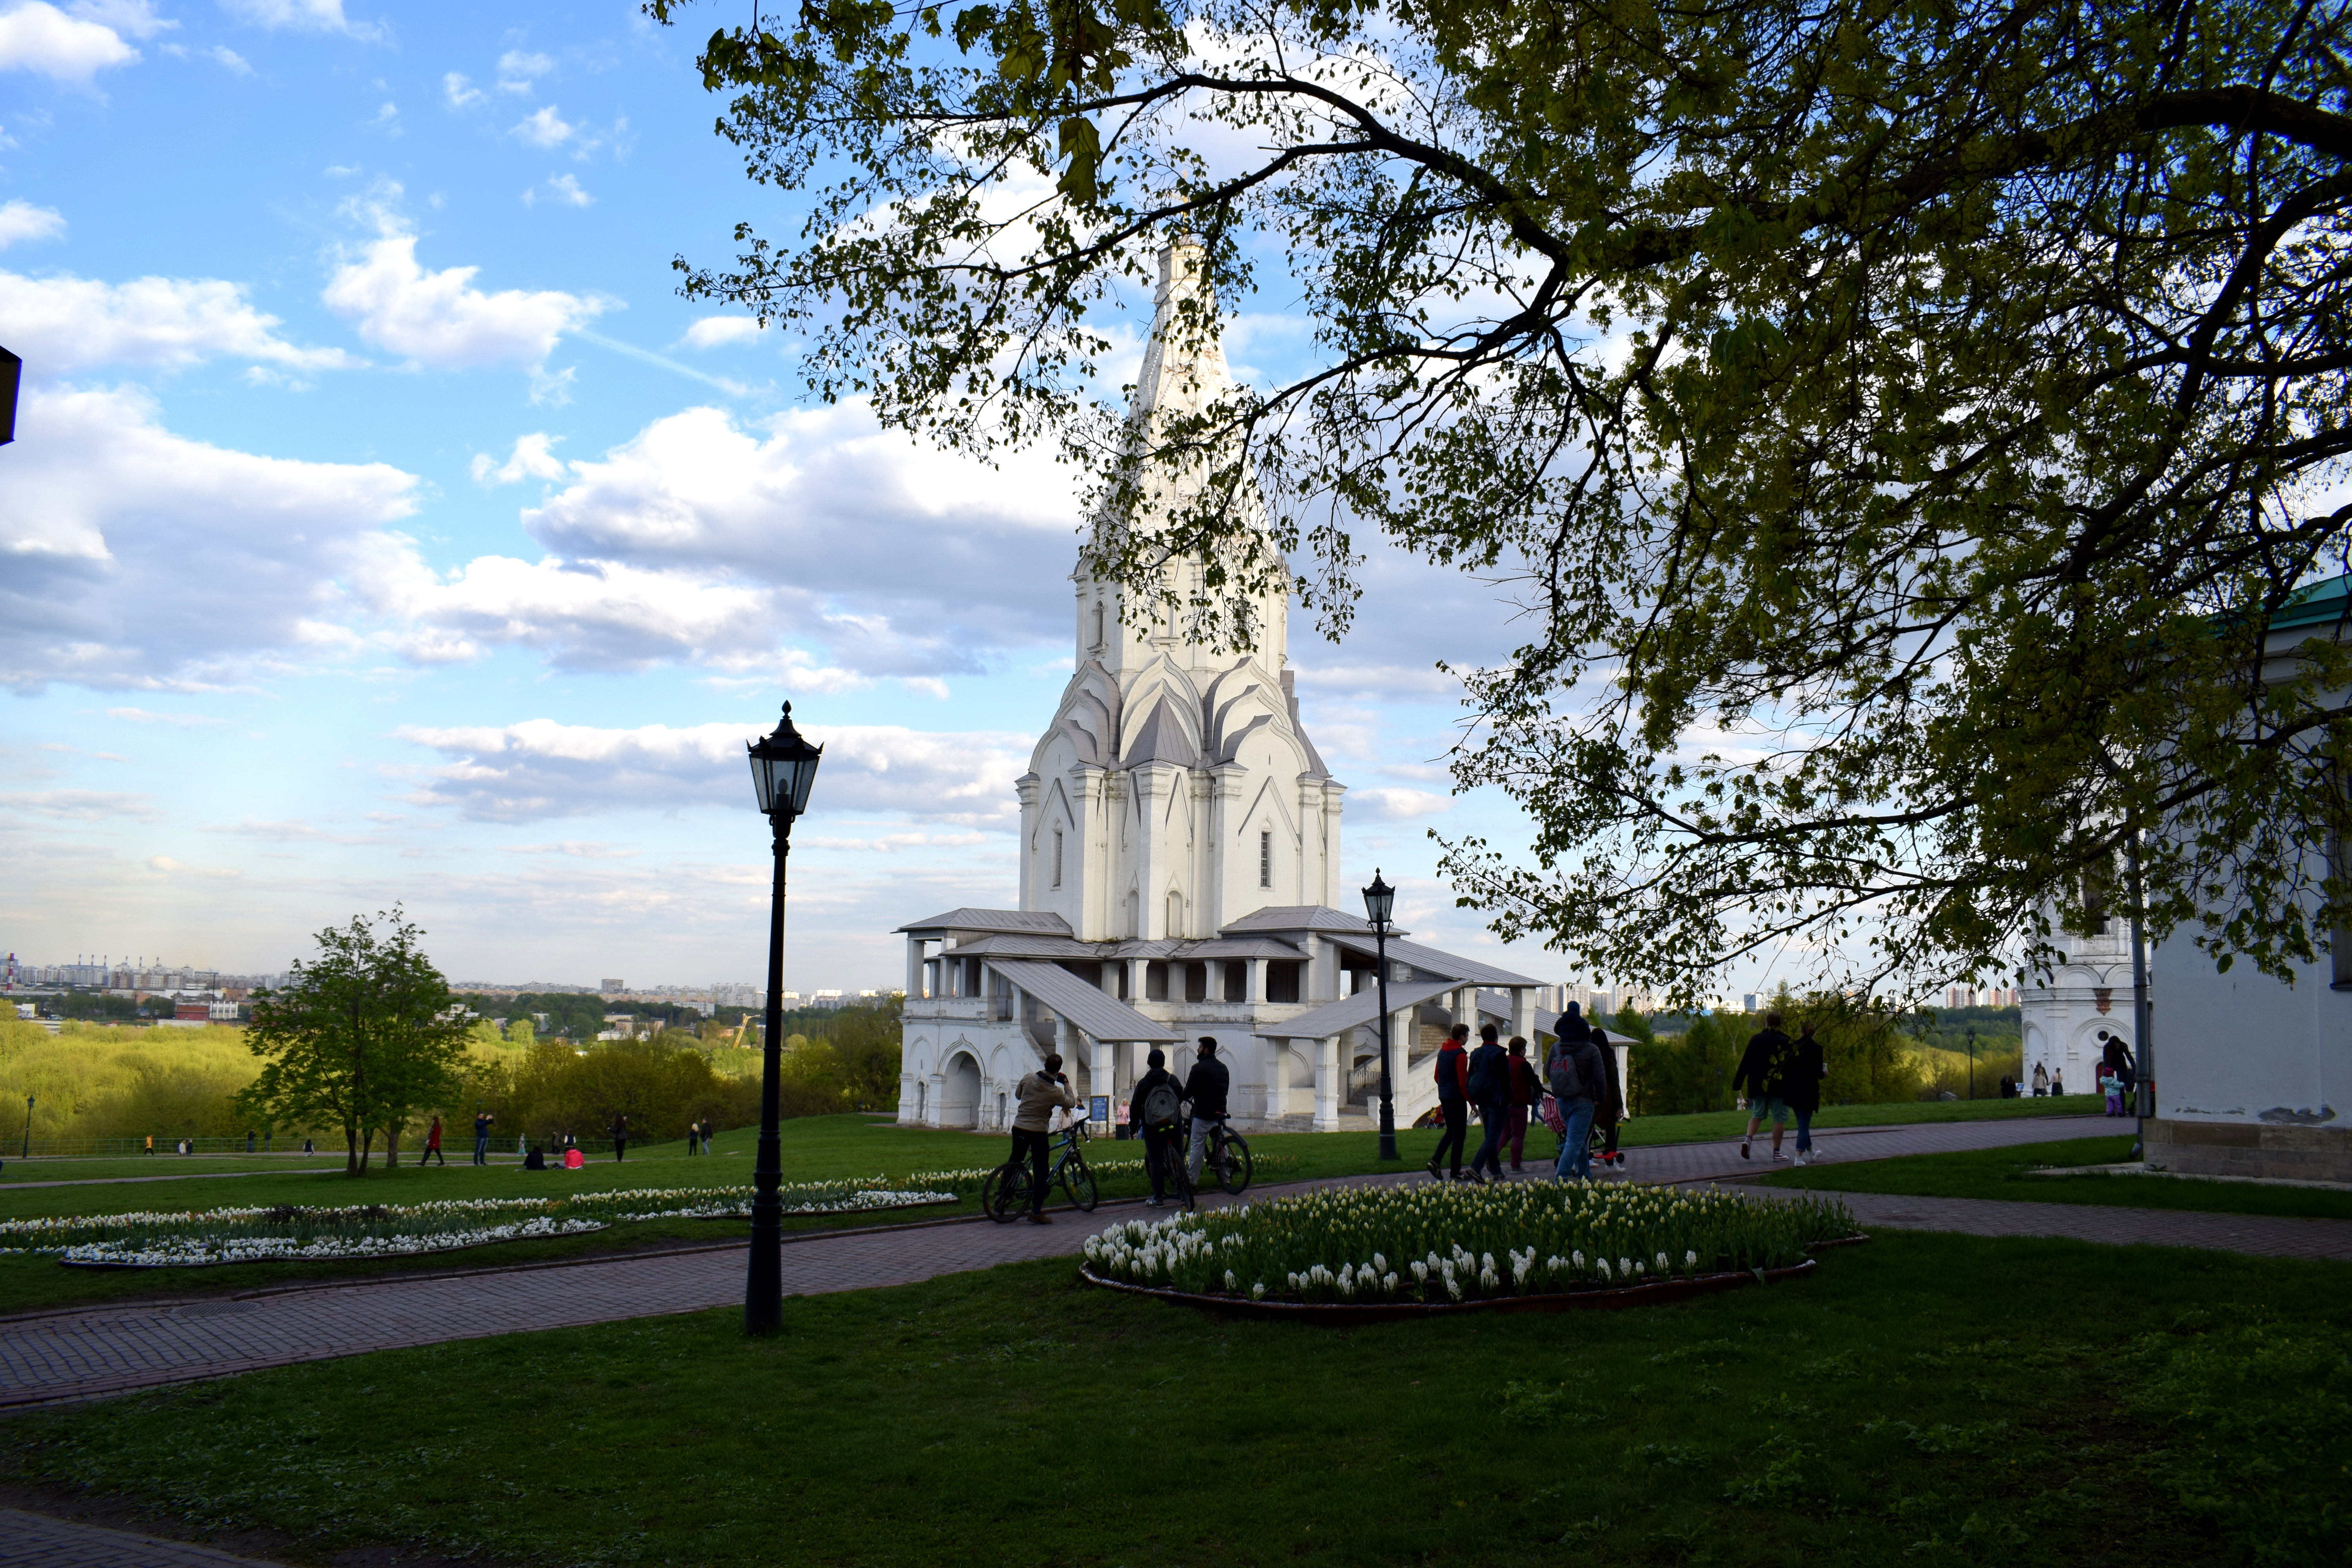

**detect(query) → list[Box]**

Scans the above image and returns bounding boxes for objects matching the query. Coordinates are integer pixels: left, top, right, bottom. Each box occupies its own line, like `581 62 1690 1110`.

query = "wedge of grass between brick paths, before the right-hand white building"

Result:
1759 1133 2352 1220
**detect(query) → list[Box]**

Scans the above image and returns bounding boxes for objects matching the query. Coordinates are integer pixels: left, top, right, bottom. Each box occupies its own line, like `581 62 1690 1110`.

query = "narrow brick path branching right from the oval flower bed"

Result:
1823 1192 2352 1262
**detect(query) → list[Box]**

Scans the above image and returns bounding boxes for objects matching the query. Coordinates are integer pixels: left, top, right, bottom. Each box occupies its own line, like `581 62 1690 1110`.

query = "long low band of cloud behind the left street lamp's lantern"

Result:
400 715 1030 828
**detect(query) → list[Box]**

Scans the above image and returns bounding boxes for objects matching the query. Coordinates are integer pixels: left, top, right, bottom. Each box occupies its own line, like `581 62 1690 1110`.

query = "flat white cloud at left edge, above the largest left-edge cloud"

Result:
0 273 355 376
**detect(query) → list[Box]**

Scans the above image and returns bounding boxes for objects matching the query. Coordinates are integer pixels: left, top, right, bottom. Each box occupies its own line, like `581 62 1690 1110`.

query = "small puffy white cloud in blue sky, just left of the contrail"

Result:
325 186 616 367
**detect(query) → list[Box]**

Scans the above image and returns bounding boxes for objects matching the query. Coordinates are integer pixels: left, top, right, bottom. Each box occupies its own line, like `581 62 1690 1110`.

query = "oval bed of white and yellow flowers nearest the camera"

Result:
1084 1182 1853 1307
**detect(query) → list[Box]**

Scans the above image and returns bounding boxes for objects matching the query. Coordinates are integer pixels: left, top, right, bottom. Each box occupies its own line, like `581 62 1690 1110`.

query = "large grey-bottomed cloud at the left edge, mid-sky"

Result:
0 388 416 693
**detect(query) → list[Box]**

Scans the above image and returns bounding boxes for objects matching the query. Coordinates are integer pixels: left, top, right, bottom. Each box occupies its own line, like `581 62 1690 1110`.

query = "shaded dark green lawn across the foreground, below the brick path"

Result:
0 1234 2352 1568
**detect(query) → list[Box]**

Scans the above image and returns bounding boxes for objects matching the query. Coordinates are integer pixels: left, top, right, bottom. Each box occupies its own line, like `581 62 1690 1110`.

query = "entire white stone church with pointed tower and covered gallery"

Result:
898 245 1552 1131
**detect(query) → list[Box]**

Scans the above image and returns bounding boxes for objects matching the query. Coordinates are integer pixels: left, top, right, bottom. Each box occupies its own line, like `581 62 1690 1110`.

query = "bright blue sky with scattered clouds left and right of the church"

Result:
0 0 1609 987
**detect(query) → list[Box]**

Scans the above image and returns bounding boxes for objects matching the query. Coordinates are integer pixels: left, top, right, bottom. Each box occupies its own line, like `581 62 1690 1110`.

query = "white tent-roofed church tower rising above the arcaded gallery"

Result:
1016 242 1345 940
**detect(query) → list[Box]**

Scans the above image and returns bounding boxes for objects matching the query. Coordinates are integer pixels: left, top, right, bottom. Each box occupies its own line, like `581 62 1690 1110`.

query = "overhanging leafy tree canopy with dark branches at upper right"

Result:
649 0 2352 992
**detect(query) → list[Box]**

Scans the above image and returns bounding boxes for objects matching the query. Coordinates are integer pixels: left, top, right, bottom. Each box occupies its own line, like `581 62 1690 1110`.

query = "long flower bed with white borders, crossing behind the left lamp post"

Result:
0 1178 955 1269
